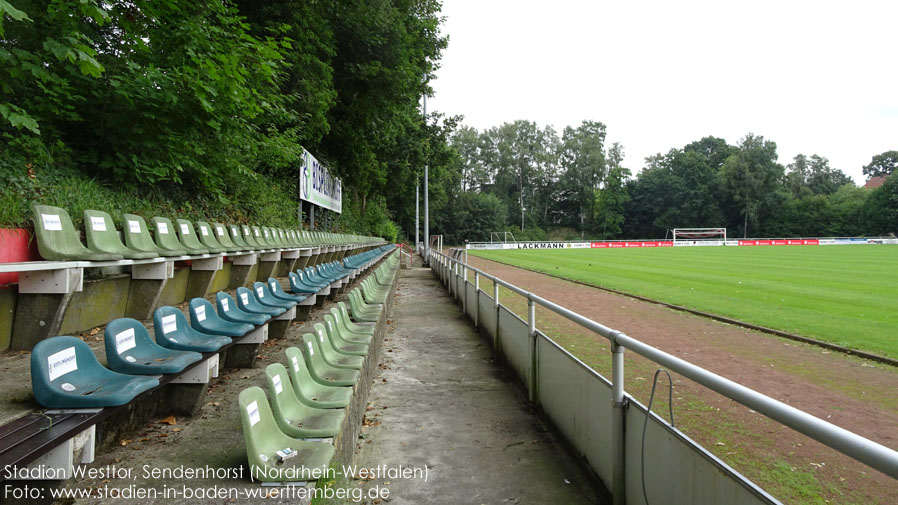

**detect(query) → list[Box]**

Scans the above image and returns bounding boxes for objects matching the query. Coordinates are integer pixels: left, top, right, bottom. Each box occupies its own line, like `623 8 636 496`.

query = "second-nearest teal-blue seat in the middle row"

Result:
104 318 203 375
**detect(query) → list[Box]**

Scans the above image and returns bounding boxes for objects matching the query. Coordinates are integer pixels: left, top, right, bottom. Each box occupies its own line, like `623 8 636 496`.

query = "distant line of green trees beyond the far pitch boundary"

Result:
435 121 898 243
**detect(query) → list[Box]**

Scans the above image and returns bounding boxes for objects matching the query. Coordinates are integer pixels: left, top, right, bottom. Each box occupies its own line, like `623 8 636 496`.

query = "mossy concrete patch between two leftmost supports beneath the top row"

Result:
59 275 131 335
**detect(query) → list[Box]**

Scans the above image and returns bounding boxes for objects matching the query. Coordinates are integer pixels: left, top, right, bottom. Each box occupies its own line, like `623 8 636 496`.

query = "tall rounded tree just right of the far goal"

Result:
720 133 783 237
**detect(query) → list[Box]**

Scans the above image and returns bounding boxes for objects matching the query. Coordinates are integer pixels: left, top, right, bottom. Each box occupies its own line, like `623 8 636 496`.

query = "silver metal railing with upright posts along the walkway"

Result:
430 249 898 505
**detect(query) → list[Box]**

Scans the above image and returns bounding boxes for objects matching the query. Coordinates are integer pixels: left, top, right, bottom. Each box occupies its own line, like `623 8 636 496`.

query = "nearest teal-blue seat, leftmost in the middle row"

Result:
31 337 159 409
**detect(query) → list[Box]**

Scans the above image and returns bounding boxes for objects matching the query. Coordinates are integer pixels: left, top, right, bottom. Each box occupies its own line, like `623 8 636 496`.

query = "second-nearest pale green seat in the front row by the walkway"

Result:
265 363 346 438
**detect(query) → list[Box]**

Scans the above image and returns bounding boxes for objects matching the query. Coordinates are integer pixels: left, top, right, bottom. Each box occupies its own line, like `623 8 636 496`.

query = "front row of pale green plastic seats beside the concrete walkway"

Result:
238 254 399 482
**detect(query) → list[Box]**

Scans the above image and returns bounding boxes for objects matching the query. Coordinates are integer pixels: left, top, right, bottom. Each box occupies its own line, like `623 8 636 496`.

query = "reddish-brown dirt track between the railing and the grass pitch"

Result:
469 257 898 504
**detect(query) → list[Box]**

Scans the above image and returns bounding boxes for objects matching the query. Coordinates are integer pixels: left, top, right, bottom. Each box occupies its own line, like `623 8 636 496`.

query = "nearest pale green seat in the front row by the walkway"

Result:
237 386 334 482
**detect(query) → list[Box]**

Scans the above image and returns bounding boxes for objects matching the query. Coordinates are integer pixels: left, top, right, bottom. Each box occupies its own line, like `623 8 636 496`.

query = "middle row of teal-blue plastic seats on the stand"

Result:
31 246 392 409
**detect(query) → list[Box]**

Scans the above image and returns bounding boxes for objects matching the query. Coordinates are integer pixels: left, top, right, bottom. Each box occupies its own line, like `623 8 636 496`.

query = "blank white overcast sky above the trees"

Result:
427 0 898 183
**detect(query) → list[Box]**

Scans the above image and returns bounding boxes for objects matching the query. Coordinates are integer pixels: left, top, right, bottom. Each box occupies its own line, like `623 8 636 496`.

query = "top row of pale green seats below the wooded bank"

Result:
32 204 373 261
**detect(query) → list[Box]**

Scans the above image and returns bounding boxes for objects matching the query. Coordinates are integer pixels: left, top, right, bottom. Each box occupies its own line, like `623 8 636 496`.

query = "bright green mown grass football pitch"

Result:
471 245 898 358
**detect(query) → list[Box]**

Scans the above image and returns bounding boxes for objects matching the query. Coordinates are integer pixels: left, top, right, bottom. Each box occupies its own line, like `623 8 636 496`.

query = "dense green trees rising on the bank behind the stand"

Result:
0 0 454 238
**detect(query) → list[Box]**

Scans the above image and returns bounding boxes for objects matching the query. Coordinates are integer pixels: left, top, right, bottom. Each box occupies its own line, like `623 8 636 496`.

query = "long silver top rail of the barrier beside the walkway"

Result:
432 250 898 479
